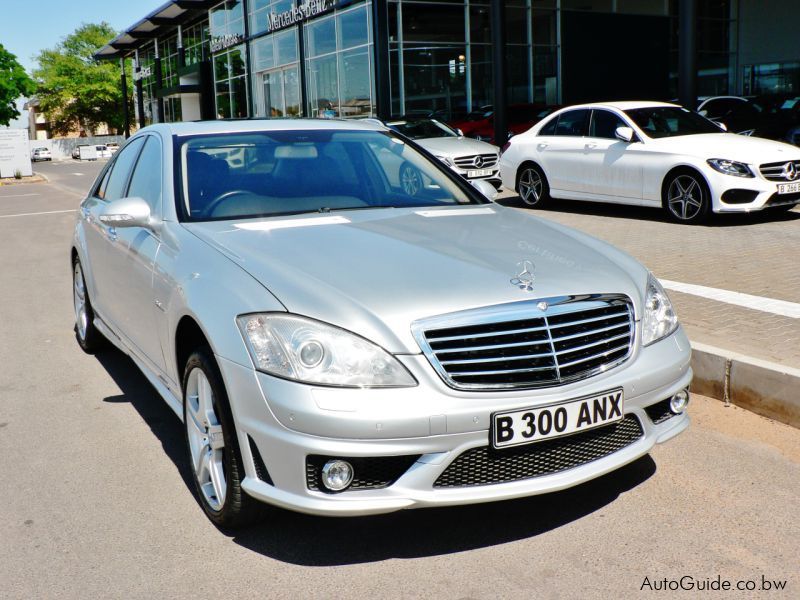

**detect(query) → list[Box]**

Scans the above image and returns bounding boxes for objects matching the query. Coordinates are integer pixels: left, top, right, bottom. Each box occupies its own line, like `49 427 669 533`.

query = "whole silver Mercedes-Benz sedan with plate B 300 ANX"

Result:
71 120 692 527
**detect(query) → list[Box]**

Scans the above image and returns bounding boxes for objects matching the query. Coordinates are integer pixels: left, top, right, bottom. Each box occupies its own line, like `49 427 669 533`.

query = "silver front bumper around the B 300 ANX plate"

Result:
219 329 692 516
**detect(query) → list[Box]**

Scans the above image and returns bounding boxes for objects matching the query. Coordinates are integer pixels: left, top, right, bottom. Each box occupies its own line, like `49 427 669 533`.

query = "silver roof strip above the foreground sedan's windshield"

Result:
141 118 385 136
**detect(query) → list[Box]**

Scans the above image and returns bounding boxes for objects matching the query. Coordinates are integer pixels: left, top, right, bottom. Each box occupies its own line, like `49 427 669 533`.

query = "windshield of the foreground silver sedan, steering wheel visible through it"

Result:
180 130 482 221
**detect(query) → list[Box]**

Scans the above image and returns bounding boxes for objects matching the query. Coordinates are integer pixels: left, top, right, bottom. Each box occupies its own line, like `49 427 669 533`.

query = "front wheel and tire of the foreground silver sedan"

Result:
183 347 261 529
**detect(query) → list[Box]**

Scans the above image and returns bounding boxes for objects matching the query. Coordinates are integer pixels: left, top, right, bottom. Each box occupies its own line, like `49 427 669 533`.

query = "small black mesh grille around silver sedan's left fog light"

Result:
306 454 420 492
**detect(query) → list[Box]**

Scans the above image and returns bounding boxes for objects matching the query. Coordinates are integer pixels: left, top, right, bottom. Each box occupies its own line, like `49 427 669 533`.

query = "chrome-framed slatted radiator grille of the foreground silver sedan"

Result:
412 295 635 389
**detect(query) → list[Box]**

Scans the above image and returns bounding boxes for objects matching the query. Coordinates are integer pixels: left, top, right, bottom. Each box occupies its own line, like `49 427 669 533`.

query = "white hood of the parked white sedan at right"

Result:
647 133 800 166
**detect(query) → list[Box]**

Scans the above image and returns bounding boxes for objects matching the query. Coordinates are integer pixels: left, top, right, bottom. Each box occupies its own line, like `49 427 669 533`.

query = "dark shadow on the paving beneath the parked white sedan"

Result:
497 196 800 228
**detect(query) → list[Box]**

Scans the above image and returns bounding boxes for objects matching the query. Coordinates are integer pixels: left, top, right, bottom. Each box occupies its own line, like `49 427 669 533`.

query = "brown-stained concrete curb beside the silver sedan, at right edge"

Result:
691 342 800 428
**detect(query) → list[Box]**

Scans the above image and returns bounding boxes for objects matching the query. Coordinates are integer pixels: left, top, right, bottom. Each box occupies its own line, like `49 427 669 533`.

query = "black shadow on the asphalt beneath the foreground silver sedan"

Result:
96 349 656 567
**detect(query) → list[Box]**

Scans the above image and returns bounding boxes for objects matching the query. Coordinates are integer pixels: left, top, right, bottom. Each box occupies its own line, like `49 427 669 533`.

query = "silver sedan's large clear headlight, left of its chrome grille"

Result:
236 313 417 387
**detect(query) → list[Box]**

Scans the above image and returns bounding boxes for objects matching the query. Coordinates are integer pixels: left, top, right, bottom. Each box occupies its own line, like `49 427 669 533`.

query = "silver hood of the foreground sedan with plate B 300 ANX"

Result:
186 205 647 353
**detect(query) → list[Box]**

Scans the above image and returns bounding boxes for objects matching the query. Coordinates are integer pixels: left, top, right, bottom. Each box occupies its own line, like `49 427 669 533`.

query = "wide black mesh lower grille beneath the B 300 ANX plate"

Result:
433 415 644 488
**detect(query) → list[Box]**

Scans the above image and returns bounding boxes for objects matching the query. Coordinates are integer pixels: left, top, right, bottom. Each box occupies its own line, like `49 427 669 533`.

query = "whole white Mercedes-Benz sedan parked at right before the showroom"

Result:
500 102 800 223
